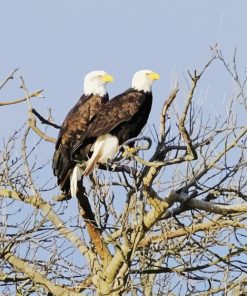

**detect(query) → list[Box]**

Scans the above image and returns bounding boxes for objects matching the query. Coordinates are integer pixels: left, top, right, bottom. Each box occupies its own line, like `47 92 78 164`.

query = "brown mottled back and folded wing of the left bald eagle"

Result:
52 95 108 193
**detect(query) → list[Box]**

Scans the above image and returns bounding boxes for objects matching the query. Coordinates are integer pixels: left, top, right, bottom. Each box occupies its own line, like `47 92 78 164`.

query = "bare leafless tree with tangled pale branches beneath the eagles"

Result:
0 47 247 296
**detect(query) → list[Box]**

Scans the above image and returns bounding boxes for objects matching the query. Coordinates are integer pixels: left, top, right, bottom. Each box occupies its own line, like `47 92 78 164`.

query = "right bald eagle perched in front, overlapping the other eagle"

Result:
70 70 159 193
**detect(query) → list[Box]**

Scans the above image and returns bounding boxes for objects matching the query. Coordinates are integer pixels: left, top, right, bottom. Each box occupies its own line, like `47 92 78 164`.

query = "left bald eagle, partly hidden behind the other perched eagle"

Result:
52 71 113 197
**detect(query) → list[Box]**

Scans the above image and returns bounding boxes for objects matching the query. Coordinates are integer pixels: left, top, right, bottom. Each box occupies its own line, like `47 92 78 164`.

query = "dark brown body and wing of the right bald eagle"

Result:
73 89 152 154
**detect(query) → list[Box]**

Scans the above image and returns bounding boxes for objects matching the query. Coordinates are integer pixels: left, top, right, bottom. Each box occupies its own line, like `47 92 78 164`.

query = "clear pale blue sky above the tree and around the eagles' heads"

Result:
0 0 247 135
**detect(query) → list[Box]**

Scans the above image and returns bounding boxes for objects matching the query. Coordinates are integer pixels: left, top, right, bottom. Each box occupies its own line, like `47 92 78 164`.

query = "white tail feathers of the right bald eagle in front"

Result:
84 134 118 176
